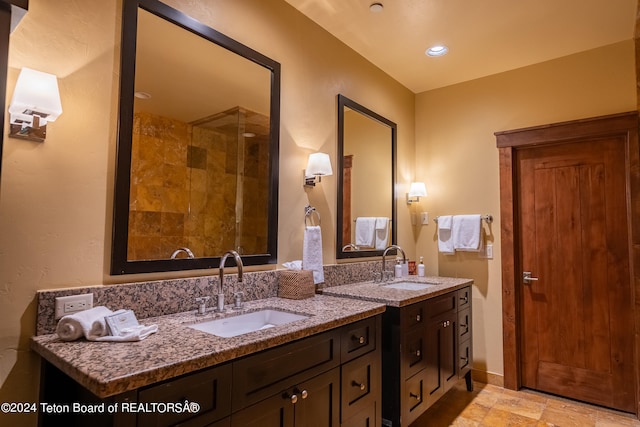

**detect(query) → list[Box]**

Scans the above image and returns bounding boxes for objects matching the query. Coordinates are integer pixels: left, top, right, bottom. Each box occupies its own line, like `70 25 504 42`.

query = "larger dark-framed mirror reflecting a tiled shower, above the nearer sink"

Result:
111 0 280 274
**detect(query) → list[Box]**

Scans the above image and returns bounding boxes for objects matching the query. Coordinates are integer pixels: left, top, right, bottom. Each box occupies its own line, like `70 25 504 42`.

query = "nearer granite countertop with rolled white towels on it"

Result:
31 295 385 398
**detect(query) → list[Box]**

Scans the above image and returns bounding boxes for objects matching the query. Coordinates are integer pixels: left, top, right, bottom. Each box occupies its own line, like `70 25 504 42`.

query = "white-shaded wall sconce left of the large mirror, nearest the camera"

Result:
9 67 62 142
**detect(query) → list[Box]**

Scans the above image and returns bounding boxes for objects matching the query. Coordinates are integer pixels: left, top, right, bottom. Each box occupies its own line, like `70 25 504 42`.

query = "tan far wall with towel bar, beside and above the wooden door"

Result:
416 40 636 375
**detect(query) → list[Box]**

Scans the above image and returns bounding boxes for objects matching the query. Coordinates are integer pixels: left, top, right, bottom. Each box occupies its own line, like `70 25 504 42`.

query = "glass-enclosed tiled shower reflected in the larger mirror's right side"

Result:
191 107 269 256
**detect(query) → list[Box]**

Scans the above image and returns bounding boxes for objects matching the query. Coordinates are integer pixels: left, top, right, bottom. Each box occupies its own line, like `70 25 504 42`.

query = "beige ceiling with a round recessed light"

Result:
286 0 638 93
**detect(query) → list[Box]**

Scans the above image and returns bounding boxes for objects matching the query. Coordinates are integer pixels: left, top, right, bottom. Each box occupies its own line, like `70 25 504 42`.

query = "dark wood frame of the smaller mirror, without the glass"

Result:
336 94 398 259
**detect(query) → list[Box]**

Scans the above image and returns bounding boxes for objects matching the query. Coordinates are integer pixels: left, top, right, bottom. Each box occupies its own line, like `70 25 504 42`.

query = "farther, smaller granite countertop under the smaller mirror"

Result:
322 276 473 307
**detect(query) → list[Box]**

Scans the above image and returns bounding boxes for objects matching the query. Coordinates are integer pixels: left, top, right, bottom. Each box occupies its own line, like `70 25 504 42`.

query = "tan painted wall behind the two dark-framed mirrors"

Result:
0 0 415 425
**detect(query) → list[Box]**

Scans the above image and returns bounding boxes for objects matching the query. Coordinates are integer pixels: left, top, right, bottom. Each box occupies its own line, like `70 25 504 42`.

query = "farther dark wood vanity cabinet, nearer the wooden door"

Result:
382 287 472 427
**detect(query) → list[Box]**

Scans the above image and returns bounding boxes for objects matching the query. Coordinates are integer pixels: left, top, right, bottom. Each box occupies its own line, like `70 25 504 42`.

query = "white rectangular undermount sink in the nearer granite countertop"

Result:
188 308 310 338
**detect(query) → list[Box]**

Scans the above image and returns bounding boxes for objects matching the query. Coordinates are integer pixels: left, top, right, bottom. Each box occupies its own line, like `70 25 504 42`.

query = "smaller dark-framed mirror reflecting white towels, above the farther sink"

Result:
336 95 397 258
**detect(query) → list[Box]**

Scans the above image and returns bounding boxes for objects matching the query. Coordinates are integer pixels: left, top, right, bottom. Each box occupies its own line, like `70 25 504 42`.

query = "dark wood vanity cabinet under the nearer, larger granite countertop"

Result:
39 316 382 427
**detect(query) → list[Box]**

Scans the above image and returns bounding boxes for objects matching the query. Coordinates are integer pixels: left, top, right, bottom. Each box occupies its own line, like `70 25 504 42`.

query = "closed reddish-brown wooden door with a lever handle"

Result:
515 136 635 411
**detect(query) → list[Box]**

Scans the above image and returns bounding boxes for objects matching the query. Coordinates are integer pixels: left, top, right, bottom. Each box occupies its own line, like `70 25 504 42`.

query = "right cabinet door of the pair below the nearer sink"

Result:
294 368 340 427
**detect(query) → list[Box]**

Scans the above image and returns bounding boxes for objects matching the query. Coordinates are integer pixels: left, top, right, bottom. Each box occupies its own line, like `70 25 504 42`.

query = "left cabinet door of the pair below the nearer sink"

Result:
231 392 295 427
